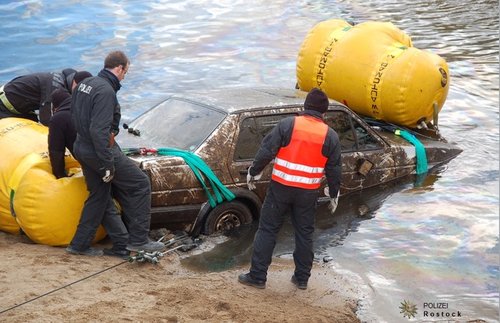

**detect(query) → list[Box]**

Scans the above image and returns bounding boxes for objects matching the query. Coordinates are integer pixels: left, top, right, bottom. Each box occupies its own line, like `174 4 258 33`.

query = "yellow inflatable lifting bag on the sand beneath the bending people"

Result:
0 118 106 246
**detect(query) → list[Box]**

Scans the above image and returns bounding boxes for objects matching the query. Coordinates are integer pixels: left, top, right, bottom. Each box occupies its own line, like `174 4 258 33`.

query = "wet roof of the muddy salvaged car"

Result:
172 87 332 113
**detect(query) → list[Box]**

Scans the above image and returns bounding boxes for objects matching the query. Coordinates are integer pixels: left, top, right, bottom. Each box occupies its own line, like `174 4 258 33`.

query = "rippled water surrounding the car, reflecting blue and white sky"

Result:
0 0 499 322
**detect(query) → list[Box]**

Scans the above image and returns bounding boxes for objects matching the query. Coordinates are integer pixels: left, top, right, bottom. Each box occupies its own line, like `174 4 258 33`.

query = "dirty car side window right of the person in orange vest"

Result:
324 111 381 152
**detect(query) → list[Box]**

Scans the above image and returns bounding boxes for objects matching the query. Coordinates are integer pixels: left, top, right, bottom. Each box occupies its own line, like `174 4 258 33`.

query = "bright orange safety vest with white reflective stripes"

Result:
272 116 328 189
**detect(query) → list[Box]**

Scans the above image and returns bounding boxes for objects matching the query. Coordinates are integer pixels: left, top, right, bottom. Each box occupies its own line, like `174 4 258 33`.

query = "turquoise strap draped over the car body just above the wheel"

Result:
157 148 235 207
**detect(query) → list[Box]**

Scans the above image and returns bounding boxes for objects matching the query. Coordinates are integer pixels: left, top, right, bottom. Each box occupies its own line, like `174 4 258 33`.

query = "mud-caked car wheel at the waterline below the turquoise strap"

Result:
205 201 252 235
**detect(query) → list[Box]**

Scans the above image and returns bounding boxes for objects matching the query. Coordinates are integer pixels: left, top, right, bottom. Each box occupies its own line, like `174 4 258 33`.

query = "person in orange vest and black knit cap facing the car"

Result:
238 88 342 289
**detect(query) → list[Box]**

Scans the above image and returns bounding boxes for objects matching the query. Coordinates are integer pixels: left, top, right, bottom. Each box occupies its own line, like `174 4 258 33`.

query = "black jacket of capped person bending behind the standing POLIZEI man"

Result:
49 97 76 178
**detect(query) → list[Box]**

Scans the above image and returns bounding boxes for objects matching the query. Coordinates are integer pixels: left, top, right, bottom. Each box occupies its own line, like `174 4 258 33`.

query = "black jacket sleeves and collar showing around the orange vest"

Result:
250 110 342 197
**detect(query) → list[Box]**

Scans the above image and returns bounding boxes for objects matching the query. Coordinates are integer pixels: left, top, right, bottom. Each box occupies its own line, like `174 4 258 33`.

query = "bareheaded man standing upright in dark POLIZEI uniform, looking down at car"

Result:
66 51 165 256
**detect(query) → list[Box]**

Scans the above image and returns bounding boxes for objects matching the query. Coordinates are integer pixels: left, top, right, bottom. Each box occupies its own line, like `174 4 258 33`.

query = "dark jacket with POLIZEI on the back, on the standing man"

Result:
71 69 121 169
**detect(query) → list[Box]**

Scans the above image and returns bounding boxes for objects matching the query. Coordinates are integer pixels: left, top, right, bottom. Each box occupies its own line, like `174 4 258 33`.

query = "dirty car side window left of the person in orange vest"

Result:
234 113 295 160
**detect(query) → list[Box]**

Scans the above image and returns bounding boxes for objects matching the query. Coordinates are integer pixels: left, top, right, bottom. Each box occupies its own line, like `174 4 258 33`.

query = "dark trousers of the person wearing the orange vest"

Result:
250 181 318 282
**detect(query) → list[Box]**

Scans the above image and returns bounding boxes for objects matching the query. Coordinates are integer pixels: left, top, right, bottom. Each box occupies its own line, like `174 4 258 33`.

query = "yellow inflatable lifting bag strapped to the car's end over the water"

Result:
297 19 449 128
